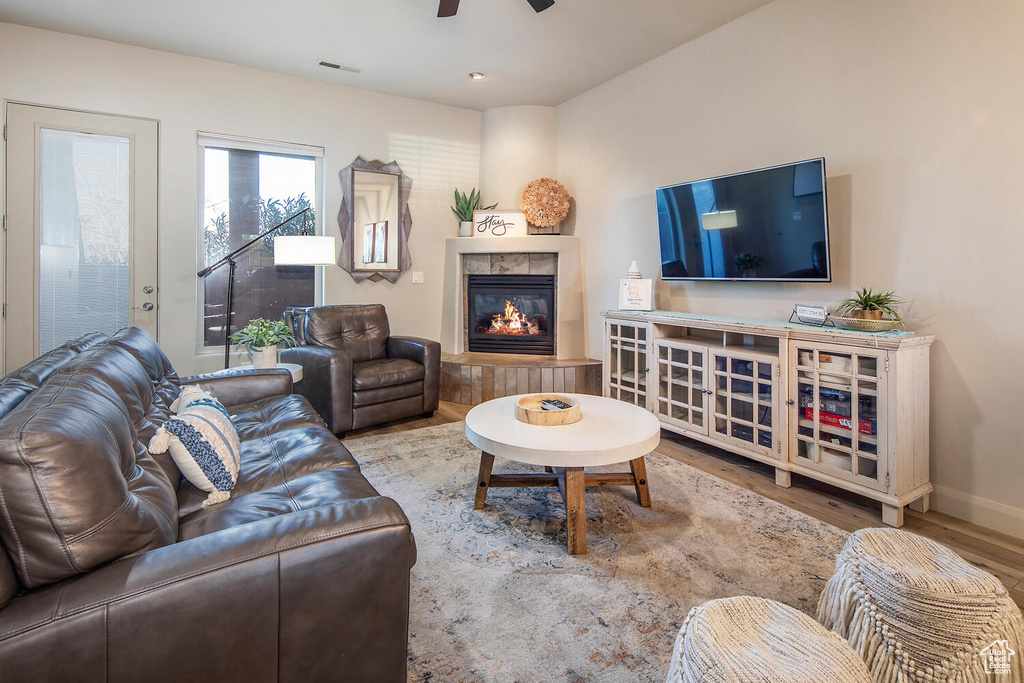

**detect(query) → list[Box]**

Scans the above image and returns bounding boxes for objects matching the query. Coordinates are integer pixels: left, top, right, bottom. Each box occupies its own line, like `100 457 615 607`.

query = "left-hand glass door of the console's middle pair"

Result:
654 341 708 434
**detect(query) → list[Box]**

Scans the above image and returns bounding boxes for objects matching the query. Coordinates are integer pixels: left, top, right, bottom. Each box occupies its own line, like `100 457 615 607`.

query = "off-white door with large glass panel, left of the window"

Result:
3 103 158 372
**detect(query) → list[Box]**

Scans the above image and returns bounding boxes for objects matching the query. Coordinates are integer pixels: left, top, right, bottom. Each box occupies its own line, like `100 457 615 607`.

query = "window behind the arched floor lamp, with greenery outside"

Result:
197 134 324 348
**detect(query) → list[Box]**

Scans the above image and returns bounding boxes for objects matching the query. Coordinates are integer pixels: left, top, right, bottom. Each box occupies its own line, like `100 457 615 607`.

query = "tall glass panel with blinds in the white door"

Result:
39 128 131 353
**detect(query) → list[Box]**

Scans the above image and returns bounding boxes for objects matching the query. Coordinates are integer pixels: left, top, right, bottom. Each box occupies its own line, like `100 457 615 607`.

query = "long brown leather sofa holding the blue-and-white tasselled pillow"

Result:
0 328 416 683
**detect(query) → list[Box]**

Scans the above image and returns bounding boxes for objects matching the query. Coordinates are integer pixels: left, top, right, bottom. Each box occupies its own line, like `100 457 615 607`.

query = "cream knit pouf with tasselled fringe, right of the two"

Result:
818 528 1024 683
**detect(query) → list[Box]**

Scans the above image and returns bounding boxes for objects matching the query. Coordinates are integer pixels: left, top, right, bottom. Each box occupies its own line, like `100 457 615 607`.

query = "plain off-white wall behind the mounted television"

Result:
556 0 1024 537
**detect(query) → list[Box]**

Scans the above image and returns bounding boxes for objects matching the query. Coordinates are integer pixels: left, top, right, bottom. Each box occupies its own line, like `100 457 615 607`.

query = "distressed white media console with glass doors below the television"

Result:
603 310 934 526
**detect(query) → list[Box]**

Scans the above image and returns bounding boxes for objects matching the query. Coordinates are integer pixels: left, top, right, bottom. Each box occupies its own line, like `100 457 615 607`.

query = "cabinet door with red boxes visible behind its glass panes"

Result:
791 343 888 490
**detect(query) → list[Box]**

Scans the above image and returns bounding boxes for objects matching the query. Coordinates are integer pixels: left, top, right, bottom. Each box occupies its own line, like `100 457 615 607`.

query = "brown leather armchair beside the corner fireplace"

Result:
281 304 441 435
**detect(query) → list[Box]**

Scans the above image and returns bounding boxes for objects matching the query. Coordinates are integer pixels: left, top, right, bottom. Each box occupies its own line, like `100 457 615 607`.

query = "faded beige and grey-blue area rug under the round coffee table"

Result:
345 423 847 683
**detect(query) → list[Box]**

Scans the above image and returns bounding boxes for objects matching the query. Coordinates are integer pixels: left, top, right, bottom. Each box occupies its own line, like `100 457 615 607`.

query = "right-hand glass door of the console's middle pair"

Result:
712 352 781 458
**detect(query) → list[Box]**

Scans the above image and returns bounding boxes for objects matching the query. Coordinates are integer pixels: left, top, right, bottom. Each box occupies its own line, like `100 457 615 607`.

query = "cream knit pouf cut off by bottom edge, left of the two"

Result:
666 596 871 683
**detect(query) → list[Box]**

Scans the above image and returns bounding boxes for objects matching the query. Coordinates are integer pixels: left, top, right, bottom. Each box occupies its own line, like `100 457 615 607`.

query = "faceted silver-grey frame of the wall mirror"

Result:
338 157 413 284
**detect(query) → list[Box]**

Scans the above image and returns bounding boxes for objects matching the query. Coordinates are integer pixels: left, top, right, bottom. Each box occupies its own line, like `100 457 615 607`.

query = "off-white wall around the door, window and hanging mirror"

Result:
0 24 480 374
